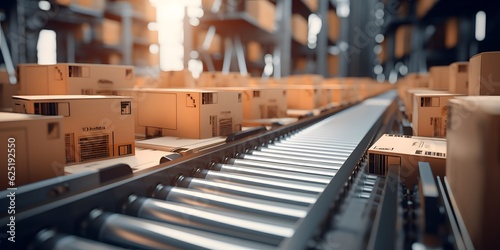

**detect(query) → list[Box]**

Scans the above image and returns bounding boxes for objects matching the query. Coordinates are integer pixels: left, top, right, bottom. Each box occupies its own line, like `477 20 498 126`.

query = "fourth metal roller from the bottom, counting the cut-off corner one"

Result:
154 185 307 221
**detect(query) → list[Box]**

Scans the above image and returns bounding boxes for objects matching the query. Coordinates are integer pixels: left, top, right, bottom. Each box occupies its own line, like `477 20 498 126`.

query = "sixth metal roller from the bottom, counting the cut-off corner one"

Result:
198 170 325 194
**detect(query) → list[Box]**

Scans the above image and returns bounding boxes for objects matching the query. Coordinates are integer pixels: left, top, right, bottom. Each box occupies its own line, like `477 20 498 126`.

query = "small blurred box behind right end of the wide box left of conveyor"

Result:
196 72 249 87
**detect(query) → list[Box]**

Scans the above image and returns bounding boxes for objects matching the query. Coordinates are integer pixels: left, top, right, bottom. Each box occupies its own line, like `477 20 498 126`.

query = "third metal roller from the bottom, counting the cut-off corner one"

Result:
126 195 294 245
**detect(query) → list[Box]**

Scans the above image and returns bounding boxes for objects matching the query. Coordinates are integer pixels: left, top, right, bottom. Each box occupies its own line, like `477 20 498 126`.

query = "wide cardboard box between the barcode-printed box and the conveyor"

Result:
133 89 243 139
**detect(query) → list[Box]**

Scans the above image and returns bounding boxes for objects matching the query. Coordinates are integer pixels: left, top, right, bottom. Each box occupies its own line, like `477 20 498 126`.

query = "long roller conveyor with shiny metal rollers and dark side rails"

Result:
0 92 397 249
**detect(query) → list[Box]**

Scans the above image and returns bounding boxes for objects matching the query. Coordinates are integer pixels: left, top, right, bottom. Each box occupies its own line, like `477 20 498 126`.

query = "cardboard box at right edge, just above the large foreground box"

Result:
469 51 500 95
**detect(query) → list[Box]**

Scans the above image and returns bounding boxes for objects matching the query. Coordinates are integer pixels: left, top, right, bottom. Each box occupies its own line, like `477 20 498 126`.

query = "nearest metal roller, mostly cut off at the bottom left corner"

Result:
33 229 125 250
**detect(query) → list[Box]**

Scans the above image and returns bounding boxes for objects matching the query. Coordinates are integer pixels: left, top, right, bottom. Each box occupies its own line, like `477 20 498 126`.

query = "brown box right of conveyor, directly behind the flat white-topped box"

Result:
412 92 460 138
